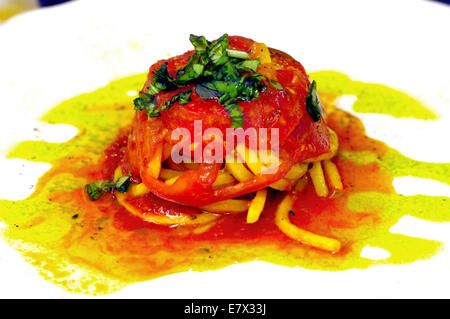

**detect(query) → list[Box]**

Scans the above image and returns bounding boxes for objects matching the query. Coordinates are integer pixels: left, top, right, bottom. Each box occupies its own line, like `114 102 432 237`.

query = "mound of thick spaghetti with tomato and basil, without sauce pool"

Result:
86 34 343 252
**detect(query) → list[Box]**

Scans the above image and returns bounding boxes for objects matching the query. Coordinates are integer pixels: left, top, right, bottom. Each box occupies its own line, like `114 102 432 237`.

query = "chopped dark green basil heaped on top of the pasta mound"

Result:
134 34 283 128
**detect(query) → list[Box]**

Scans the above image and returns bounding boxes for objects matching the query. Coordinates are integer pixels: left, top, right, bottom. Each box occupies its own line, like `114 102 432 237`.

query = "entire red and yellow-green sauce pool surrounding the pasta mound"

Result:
0 71 450 294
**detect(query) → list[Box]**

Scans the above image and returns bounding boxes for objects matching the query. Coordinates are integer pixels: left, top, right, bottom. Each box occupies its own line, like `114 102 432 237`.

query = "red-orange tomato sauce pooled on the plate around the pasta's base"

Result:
37 96 393 286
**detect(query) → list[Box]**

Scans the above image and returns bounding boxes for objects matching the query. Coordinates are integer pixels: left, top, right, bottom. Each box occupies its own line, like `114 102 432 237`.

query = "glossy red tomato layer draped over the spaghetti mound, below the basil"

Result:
123 36 330 207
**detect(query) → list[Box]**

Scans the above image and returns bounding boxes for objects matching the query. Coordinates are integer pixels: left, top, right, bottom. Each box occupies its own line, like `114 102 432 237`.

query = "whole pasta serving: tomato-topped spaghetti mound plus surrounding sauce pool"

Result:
0 34 448 294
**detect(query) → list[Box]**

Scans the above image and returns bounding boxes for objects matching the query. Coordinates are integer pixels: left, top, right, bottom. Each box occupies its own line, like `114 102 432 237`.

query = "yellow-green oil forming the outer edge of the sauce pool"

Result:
0 71 450 294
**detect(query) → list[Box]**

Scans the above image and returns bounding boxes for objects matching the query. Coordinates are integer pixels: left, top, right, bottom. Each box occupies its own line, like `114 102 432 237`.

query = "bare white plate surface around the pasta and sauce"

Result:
0 0 450 298
